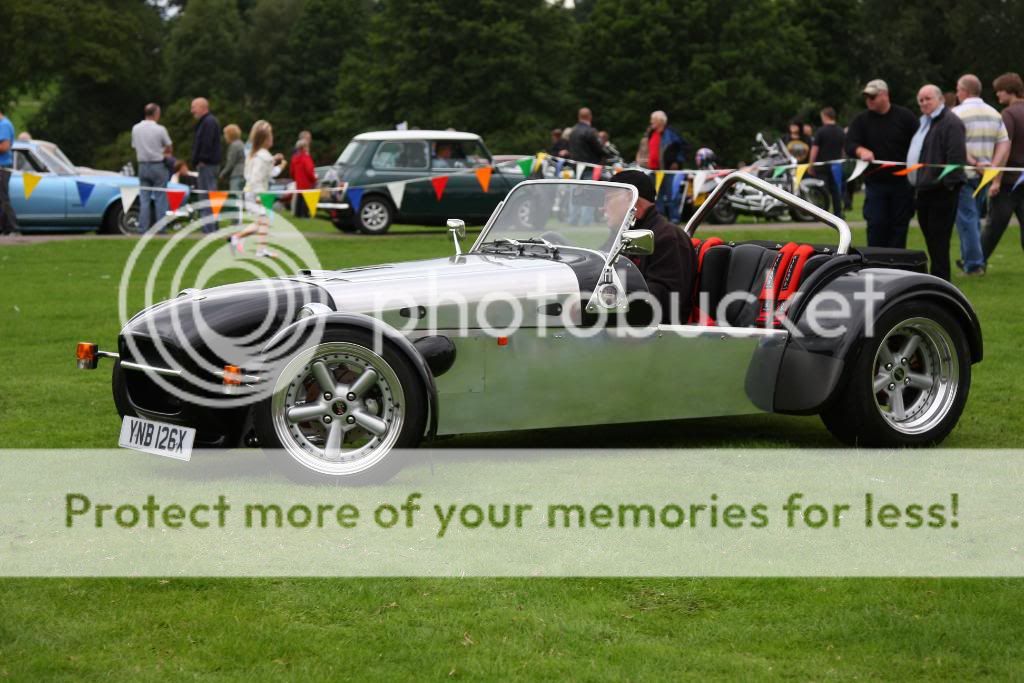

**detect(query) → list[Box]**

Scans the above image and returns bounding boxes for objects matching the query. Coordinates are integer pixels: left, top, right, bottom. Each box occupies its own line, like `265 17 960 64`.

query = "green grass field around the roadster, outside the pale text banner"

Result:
0 215 1024 680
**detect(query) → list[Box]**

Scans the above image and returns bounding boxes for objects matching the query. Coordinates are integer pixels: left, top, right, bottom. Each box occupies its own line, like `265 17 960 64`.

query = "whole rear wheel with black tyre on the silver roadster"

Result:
821 302 971 447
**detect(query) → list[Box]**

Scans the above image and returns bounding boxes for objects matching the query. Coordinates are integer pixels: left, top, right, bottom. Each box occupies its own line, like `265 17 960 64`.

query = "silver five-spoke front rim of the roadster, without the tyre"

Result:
270 342 406 476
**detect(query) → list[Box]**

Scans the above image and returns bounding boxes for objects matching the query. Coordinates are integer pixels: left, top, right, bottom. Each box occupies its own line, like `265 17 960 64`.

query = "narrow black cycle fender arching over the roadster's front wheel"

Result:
263 311 438 438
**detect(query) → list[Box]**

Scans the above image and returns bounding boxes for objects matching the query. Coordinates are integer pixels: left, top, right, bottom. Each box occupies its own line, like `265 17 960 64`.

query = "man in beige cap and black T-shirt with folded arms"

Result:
846 79 918 249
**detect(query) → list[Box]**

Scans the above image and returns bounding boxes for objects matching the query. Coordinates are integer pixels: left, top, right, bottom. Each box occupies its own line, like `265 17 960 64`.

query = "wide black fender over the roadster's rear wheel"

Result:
773 267 984 415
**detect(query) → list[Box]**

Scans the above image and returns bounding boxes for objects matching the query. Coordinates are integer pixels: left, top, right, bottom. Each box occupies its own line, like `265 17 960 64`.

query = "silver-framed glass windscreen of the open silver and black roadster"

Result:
481 180 636 251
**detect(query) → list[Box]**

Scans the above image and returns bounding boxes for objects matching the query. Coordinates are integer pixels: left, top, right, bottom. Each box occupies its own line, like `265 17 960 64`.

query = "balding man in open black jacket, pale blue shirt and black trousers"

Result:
906 85 967 280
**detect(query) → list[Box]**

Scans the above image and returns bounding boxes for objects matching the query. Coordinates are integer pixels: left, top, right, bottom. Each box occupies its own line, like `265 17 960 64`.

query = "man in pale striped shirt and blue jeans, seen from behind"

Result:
953 74 1010 275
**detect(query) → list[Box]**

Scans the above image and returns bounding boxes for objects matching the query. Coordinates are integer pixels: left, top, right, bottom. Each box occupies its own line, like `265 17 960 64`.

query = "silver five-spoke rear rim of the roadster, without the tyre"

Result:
871 317 959 434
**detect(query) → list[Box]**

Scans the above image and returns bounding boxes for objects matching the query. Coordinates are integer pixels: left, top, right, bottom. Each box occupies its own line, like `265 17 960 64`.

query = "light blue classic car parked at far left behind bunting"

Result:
9 140 188 234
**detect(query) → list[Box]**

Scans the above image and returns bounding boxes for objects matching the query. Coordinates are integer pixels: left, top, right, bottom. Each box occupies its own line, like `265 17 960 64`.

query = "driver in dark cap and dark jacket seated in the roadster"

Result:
611 170 697 325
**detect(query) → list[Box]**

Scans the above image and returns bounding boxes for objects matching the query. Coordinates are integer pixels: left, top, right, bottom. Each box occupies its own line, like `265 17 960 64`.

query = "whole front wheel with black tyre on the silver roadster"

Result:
253 328 428 485
